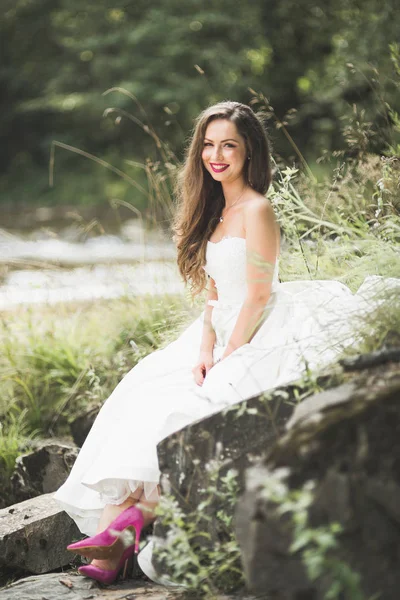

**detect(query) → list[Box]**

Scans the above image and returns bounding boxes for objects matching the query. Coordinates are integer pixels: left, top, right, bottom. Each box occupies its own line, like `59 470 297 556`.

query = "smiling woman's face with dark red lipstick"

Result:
201 119 247 183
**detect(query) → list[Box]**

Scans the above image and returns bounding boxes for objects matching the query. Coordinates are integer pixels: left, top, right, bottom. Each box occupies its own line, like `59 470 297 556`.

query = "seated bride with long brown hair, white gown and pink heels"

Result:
55 101 382 583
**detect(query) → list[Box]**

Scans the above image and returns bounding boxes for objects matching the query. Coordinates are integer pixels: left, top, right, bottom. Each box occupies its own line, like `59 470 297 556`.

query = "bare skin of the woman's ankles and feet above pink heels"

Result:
91 486 160 570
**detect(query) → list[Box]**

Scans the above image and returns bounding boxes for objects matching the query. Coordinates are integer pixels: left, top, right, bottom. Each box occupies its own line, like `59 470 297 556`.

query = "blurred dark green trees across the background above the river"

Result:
0 0 400 207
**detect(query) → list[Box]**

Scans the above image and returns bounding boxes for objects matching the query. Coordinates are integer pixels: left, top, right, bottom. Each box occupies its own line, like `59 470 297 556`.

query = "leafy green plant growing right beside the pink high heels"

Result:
156 461 243 599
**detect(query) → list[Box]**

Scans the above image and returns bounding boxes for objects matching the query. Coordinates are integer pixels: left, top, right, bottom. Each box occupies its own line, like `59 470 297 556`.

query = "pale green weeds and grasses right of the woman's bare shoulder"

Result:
269 149 400 291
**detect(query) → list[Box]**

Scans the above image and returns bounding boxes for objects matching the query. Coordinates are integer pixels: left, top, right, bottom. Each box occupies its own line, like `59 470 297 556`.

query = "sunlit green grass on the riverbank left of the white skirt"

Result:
0 297 194 435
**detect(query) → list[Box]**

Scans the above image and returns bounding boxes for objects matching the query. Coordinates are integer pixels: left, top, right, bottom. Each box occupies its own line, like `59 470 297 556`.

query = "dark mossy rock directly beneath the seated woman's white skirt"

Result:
153 387 293 575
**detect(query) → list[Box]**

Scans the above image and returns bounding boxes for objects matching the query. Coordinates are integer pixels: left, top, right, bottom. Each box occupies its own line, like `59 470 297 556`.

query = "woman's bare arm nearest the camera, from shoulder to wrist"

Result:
222 198 279 359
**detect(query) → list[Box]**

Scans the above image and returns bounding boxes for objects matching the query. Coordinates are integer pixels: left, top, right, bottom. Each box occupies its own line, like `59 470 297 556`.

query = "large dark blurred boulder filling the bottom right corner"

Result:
236 362 400 600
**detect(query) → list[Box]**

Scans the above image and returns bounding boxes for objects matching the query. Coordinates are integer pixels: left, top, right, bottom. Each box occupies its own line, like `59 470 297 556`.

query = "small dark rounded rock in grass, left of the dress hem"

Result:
11 443 78 502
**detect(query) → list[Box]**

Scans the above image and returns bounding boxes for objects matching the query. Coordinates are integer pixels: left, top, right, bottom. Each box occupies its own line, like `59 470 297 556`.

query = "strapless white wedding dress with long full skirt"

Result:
55 237 400 535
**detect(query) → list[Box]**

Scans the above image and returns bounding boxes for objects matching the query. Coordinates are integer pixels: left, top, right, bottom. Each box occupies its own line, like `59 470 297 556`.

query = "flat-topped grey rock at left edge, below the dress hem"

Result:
0 494 82 574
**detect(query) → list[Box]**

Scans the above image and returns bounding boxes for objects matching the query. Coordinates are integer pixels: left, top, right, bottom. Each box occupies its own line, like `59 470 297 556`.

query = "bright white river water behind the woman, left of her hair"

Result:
0 220 183 310
